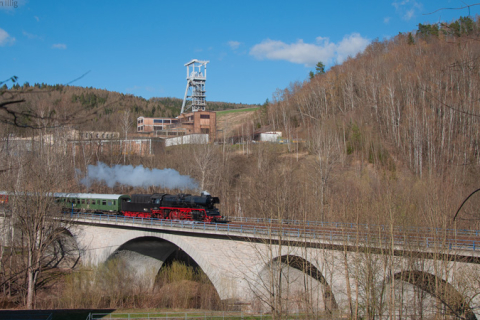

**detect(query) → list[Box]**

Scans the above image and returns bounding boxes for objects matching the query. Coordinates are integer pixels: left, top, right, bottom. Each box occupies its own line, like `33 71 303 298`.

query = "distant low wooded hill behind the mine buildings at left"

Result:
2 82 258 131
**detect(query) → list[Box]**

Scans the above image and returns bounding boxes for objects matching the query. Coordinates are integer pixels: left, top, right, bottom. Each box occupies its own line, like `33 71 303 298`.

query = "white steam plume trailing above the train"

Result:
80 162 198 189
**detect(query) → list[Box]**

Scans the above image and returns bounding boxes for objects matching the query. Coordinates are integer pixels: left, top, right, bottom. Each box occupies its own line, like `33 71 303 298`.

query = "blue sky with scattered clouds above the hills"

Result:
0 0 480 103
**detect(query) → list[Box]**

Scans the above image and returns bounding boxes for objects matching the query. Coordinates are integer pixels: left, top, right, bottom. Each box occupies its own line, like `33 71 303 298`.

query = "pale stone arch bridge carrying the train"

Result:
5 214 480 319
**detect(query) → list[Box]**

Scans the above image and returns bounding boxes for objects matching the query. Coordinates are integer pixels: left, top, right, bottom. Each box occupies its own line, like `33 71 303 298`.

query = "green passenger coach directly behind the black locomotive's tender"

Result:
54 193 130 212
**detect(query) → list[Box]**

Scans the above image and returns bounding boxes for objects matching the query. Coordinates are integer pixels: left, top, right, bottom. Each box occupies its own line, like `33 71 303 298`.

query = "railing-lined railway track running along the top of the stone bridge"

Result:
71 213 480 251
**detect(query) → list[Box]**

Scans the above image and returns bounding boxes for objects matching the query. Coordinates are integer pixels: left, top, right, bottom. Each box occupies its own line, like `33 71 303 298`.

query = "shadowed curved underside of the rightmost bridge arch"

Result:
385 270 477 320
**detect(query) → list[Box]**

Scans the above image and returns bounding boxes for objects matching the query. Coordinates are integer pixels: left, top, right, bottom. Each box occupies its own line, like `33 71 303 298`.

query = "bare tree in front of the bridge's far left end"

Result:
2 124 78 309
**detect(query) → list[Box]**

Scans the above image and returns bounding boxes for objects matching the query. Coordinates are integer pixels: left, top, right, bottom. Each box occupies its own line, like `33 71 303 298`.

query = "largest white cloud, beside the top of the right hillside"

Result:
250 33 370 67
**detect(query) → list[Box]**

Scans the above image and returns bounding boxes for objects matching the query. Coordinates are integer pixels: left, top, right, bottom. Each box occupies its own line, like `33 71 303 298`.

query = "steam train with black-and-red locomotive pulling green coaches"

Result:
0 191 225 223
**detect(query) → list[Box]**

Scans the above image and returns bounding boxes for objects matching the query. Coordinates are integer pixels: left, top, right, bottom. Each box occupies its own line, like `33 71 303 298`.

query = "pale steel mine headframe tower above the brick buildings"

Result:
180 59 210 114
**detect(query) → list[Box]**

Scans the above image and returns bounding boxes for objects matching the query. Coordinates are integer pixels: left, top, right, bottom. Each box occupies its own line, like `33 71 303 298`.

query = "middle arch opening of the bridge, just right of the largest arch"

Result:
259 254 338 313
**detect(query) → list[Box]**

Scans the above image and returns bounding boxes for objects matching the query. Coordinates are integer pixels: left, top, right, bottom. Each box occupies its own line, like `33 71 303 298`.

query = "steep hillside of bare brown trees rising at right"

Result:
258 18 480 188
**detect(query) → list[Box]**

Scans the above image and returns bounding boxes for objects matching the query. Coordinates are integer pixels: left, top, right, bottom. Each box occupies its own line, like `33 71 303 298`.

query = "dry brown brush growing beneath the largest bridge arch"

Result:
37 260 222 310
